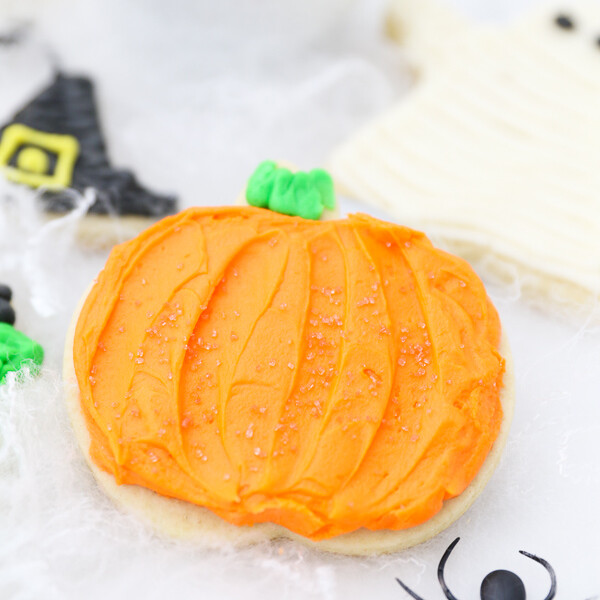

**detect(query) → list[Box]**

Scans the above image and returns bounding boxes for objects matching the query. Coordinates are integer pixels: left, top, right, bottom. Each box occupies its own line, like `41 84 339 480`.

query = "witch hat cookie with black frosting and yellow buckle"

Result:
0 28 176 241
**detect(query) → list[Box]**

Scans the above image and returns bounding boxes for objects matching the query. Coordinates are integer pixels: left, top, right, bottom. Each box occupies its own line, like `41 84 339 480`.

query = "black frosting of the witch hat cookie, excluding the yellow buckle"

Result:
0 73 176 217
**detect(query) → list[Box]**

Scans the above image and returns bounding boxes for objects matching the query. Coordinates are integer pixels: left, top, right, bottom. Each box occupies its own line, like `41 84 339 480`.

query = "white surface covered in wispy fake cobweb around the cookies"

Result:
0 0 600 600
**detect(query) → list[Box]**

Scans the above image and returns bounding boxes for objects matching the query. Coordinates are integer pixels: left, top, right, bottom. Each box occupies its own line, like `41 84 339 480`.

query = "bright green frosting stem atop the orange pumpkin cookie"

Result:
246 160 335 220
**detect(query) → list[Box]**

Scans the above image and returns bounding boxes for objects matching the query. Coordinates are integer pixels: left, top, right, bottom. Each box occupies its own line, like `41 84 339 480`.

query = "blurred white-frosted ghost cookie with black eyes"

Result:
331 0 600 314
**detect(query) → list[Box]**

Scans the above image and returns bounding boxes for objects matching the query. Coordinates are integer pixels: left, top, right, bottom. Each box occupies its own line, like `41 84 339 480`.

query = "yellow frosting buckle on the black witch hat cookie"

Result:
0 123 79 189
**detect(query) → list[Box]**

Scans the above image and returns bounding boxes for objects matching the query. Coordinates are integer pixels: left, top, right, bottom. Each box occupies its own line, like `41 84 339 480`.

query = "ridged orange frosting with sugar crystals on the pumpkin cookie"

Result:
73 207 504 540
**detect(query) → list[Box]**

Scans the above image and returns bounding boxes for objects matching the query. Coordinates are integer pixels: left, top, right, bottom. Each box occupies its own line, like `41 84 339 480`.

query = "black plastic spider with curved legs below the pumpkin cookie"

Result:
396 538 556 600
